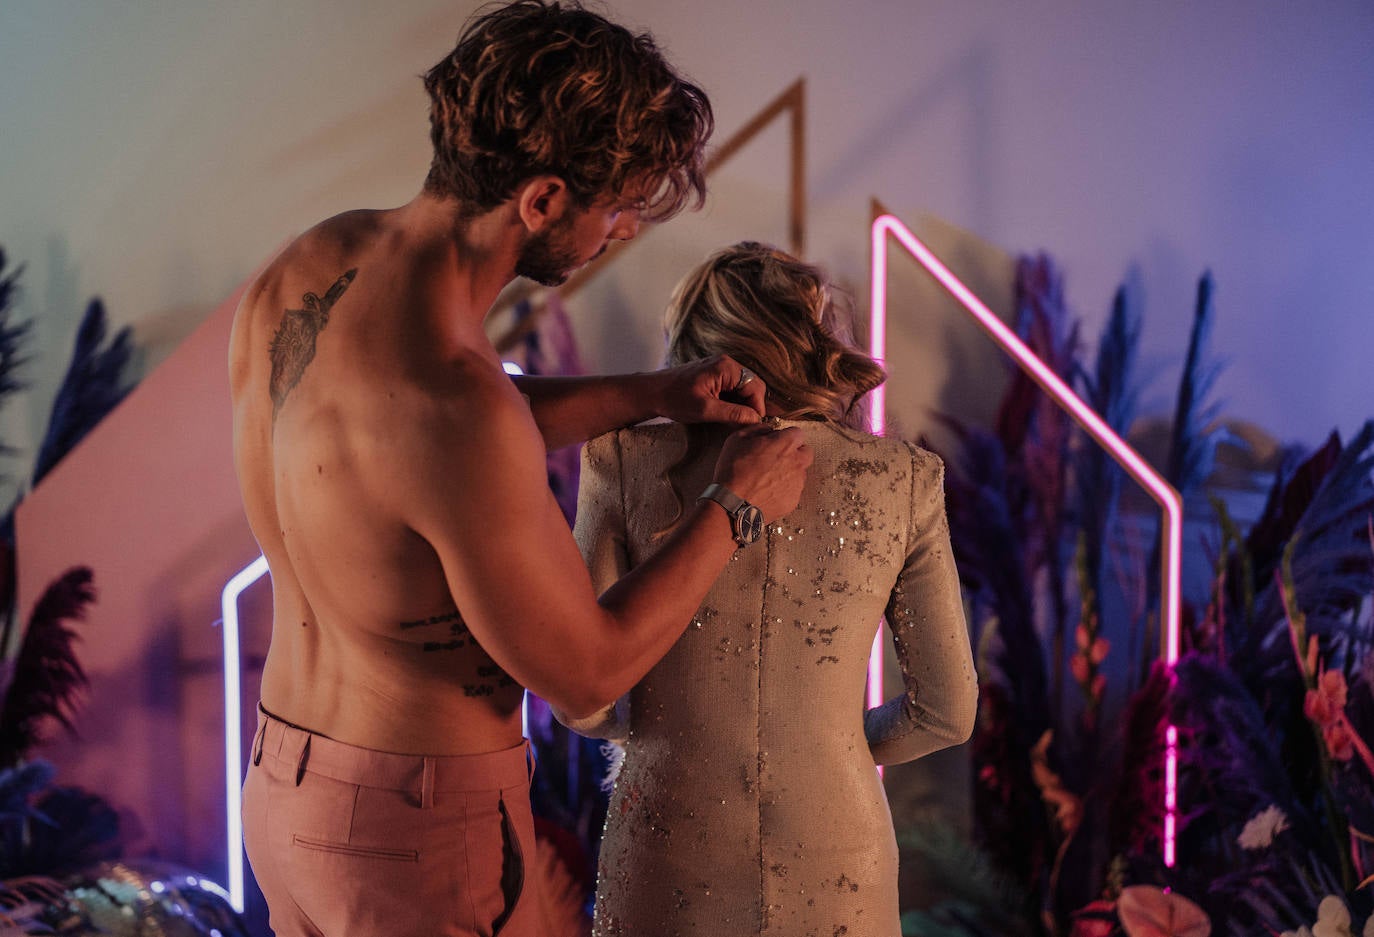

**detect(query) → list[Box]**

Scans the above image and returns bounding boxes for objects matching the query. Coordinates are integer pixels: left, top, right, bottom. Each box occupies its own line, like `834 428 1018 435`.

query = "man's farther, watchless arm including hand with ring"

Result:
511 354 767 449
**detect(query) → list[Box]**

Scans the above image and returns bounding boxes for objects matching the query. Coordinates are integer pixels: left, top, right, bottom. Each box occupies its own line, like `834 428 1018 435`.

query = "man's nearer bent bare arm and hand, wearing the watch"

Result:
387 368 811 717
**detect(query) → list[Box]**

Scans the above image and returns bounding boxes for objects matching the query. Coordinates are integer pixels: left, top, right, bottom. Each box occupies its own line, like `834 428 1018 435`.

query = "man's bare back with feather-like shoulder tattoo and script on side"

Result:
231 204 536 754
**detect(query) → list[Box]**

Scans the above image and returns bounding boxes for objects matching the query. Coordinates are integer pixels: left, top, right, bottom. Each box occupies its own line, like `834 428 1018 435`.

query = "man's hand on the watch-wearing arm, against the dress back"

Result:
712 420 813 521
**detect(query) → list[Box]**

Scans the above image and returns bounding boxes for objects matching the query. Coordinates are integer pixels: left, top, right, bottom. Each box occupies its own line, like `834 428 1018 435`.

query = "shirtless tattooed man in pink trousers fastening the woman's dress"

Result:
229 0 811 937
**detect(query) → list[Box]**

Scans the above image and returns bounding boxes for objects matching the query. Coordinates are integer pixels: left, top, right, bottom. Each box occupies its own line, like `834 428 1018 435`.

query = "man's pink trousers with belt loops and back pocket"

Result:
243 712 544 937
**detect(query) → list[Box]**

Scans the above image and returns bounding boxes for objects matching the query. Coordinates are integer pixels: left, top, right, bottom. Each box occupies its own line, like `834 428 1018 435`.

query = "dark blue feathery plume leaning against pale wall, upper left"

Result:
33 300 133 485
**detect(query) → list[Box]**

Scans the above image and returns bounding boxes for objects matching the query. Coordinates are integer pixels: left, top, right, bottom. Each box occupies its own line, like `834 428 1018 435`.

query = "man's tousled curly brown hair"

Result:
425 0 714 221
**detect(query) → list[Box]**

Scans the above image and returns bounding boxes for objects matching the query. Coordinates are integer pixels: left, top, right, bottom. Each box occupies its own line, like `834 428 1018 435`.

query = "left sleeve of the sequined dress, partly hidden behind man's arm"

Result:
554 433 629 741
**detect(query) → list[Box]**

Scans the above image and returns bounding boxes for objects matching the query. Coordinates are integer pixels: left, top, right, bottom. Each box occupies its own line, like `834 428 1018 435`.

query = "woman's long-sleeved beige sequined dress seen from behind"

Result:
572 422 977 937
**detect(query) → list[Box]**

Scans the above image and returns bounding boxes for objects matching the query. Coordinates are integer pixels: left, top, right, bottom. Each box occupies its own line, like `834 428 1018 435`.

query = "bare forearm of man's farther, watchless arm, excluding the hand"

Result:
511 372 661 451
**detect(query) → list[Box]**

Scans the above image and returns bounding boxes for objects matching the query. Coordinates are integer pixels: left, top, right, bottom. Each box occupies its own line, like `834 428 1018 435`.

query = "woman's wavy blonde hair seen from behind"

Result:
664 240 886 429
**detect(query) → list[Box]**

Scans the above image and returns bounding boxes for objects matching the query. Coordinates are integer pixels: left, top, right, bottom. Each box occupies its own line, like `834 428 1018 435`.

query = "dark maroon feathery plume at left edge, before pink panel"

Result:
0 566 95 765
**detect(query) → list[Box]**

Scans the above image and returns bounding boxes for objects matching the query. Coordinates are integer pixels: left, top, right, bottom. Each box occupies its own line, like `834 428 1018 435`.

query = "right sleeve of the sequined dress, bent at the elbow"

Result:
864 447 978 764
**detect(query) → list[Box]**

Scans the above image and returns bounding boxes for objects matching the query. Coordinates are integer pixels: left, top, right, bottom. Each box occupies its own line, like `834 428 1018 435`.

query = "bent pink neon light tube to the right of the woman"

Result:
868 214 1183 867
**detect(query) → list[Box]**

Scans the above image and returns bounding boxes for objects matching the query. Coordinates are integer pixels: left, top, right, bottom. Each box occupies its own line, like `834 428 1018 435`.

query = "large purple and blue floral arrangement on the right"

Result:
901 257 1374 937
